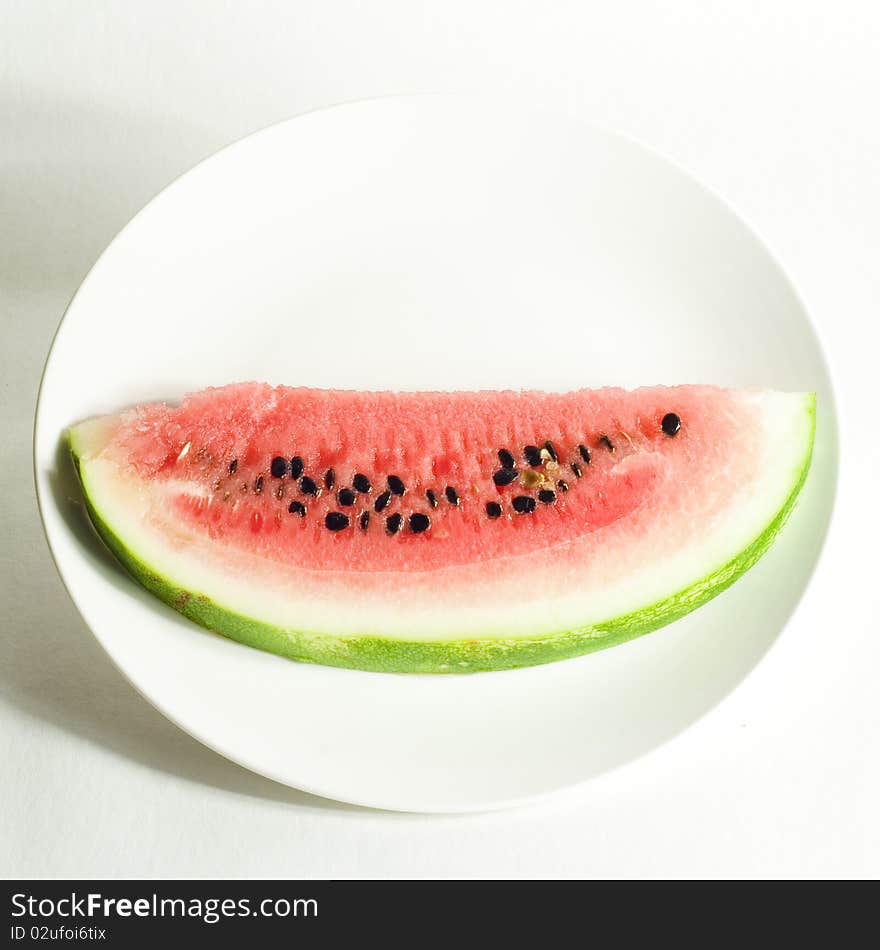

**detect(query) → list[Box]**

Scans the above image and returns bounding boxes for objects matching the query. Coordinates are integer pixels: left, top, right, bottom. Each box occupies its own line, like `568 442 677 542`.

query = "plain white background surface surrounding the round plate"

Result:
0 0 880 877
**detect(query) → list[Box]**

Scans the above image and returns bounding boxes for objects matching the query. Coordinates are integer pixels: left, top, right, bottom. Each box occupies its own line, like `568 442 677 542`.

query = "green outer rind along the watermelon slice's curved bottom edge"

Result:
69 394 816 673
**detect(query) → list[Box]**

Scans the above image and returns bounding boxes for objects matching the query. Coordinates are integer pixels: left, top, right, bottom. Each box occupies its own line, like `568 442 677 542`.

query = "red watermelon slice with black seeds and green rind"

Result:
69 383 815 673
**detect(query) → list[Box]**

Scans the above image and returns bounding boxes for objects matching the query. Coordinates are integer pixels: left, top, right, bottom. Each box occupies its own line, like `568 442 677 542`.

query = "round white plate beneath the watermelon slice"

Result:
35 97 836 811
